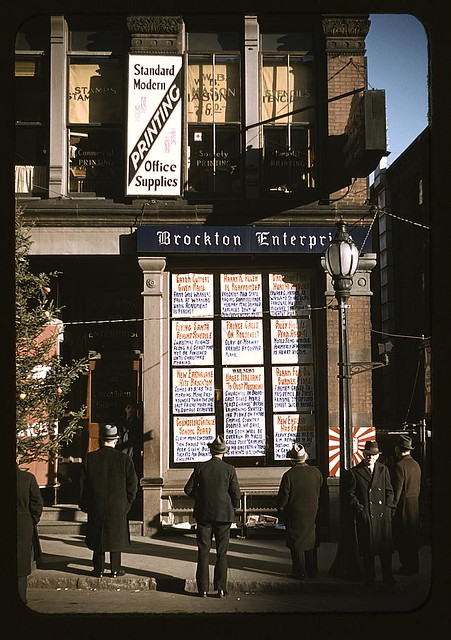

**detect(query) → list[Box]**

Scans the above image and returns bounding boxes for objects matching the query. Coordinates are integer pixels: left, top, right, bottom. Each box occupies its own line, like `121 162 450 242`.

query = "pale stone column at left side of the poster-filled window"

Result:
138 257 168 535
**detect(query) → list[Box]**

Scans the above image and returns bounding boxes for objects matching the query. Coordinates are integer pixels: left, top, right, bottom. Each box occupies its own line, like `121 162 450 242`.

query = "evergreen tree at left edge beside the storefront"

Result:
15 208 87 462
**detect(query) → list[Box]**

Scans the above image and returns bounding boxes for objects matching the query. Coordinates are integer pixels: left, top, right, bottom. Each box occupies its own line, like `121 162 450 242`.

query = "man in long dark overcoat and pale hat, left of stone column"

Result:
80 425 138 578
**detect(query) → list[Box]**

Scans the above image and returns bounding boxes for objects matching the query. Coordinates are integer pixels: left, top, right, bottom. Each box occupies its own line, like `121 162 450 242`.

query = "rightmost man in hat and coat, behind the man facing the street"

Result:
392 435 421 576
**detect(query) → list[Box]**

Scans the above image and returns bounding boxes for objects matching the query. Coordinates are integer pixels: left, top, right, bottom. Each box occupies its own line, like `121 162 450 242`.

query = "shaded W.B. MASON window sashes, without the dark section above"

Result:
187 54 241 194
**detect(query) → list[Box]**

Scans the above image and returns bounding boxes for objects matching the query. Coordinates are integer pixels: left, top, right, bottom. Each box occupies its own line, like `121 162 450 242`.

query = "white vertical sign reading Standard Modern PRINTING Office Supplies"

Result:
126 55 182 196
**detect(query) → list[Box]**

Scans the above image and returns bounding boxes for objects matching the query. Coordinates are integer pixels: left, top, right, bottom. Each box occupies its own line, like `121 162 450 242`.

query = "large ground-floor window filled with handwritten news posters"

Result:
171 272 316 466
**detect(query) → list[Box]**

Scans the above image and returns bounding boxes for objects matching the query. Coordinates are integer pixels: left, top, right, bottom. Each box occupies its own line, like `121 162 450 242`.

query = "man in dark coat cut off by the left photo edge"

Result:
17 465 44 604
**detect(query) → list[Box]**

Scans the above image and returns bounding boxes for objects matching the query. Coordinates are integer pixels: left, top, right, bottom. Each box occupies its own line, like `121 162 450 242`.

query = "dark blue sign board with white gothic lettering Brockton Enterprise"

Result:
136 225 370 255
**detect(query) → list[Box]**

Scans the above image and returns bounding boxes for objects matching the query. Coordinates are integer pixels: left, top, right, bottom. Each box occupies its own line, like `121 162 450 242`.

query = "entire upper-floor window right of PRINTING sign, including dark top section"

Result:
186 17 242 195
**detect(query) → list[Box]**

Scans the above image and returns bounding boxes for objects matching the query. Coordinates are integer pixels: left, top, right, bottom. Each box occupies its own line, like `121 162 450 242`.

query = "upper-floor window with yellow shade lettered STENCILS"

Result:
261 54 315 194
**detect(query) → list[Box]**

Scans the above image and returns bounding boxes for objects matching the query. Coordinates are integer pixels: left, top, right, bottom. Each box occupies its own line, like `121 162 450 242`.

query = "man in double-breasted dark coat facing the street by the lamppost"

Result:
349 440 395 585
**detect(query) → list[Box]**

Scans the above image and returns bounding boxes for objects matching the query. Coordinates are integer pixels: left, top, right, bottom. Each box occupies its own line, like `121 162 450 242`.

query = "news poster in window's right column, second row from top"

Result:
271 318 313 364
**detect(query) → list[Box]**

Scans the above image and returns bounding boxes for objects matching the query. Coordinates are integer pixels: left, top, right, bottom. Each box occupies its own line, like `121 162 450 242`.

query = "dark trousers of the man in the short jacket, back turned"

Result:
196 521 231 591
